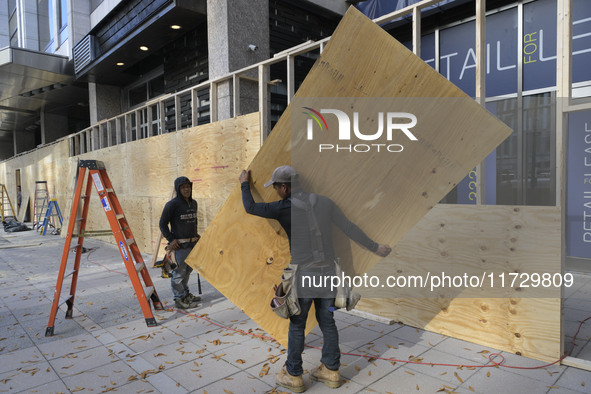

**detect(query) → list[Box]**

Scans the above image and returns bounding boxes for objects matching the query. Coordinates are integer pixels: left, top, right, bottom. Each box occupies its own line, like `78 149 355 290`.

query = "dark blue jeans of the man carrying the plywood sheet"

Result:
285 298 341 376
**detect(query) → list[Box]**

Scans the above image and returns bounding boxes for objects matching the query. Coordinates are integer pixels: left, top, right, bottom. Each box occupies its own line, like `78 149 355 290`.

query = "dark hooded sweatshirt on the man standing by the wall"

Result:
160 176 197 242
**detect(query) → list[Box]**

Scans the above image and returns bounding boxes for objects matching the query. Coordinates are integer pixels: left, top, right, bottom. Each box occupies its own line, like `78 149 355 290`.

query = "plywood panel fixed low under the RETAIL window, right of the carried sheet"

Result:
357 205 561 361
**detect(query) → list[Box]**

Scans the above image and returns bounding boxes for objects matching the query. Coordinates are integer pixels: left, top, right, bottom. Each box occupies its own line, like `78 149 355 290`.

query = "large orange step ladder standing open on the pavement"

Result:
45 160 164 337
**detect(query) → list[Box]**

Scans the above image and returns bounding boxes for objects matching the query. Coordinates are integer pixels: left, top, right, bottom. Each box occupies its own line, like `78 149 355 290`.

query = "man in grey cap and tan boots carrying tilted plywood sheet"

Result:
239 165 392 392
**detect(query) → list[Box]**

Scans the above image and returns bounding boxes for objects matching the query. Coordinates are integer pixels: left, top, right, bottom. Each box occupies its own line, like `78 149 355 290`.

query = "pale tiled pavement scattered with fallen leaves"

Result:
0 231 591 394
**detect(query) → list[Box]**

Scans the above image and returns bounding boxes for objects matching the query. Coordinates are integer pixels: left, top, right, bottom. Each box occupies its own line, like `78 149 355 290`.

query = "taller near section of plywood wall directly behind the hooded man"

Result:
72 113 260 253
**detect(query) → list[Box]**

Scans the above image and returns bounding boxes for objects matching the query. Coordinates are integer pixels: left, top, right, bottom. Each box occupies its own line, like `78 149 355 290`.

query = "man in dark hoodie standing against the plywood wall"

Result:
160 176 201 309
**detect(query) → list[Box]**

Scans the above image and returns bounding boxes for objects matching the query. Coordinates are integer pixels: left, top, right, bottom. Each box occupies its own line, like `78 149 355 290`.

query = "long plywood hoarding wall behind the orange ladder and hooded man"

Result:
0 113 260 263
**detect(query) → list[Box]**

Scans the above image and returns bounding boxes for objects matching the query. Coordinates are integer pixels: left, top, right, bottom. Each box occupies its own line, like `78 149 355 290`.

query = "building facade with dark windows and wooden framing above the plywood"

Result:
0 0 591 270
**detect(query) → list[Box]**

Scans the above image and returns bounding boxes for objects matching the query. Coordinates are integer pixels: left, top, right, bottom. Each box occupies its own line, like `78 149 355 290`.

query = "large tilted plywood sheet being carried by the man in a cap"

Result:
188 8 511 345
